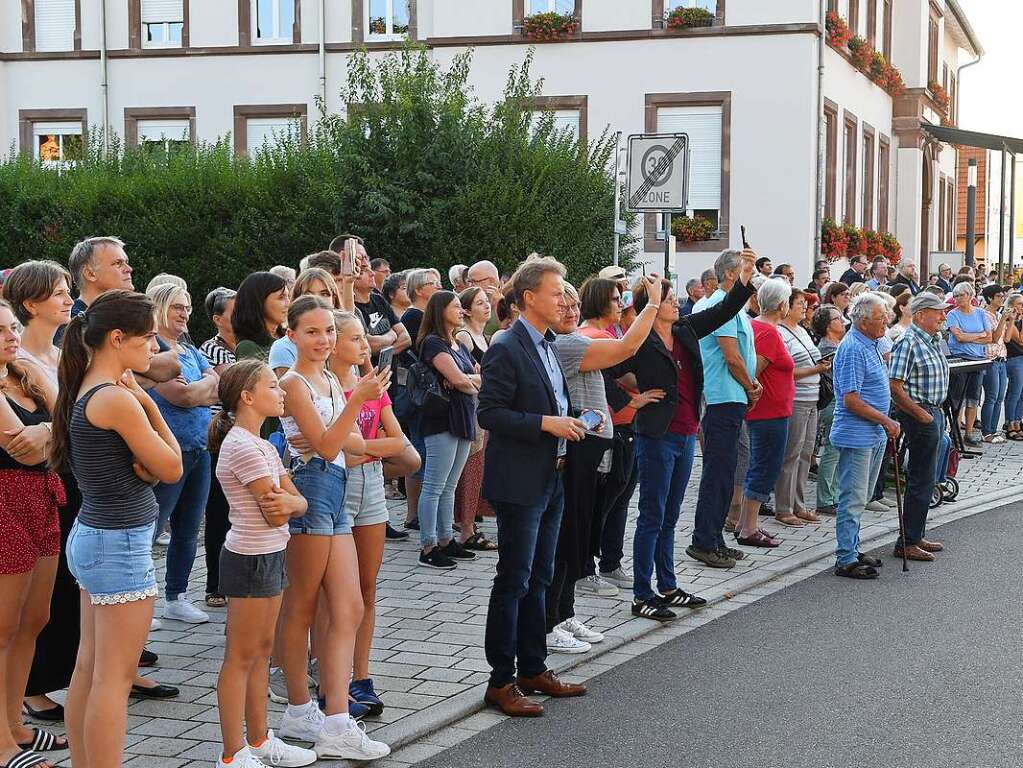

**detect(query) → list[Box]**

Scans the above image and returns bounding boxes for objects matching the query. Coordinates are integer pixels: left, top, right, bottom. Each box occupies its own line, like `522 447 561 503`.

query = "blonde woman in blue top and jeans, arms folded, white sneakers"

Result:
147 283 220 624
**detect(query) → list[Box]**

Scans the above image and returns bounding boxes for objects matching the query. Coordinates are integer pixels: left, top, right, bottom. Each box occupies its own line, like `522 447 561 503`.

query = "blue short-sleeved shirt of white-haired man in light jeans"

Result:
831 328 891 448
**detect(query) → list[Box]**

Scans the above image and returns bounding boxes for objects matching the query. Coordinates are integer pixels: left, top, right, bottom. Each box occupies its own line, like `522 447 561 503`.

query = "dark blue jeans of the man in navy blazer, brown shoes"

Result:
484 472 565 687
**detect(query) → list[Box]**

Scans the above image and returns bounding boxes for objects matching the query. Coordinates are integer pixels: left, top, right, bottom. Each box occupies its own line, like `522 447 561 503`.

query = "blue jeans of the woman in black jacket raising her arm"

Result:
632 432 697 600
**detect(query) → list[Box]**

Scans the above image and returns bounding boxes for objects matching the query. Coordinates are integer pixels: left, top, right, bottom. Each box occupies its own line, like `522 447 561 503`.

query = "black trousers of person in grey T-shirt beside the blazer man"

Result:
544 435 611 632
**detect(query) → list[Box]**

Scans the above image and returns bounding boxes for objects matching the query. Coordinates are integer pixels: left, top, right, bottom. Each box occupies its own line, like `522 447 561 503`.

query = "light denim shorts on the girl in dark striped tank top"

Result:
68 521 157 605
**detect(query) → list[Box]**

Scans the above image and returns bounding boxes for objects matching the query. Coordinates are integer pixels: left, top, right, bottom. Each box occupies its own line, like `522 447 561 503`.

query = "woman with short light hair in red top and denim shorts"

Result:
736 279 803 547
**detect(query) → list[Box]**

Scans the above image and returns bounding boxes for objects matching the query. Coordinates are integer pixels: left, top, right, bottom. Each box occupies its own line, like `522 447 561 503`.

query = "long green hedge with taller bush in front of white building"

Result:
0 47 636 337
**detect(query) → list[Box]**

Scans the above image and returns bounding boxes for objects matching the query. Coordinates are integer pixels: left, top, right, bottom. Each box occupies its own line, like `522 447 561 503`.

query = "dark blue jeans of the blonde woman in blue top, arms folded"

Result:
153 448 210 600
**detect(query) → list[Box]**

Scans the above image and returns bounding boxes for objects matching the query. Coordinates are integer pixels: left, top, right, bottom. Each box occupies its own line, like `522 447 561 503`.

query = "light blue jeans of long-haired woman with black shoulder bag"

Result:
416 432 472 548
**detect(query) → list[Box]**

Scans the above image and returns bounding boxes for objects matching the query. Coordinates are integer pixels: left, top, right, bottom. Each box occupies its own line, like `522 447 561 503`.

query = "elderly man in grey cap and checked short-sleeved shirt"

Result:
889 291 948 561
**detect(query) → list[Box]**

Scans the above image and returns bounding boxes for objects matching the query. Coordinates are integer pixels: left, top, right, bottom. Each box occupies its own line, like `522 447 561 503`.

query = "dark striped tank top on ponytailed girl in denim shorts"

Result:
71 383 160 529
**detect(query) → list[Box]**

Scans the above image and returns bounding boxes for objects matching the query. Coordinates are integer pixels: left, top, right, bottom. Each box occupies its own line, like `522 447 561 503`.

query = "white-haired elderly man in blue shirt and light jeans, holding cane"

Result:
830 292 900 579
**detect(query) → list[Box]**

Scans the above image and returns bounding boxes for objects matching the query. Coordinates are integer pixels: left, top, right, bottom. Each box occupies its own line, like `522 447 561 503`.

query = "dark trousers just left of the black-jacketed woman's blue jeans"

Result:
584 426 639 576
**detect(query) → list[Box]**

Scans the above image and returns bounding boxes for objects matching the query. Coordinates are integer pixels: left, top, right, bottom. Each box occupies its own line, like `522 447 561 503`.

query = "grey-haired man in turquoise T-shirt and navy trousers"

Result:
685 251 763 568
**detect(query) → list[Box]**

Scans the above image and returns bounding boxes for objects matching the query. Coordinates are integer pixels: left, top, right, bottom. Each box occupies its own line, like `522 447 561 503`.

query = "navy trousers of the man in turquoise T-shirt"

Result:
693 403 746 551
